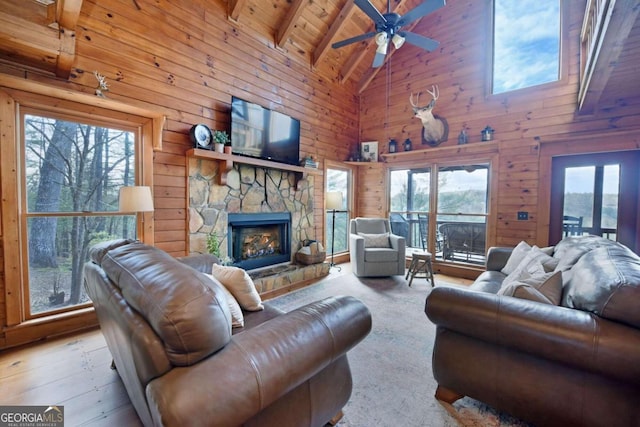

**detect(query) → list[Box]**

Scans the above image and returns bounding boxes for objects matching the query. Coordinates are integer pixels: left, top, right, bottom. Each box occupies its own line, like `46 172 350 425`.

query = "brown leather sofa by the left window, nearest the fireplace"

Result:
84 240 371 426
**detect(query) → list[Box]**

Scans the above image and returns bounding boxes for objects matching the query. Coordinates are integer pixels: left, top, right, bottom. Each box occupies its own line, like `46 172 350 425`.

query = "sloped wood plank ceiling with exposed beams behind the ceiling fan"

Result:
229 0 441 91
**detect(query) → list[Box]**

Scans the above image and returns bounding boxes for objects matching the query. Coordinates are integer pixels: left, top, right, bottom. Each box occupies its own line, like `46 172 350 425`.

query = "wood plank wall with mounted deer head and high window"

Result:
359 0 640 245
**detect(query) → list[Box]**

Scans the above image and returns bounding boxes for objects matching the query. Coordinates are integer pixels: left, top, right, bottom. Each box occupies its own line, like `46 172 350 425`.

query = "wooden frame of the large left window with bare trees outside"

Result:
0 75 160 347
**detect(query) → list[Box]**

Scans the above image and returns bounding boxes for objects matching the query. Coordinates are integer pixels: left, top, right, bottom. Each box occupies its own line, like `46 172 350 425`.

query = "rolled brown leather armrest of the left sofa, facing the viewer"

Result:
147 296 371 426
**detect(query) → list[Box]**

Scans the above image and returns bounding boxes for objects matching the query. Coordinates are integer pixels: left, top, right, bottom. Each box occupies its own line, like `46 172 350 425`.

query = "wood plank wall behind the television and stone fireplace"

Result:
0 0 358 347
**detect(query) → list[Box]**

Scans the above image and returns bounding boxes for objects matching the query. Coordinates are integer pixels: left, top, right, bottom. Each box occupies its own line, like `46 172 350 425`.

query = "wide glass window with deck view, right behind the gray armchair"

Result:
389 164 489 264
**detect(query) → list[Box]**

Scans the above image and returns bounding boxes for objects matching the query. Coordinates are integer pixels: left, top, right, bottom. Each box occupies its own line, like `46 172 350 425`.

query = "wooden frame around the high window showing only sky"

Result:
485 0 570 101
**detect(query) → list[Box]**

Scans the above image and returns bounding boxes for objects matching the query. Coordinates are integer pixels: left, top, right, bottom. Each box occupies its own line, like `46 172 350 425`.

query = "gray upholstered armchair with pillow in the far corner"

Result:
349 218 406 277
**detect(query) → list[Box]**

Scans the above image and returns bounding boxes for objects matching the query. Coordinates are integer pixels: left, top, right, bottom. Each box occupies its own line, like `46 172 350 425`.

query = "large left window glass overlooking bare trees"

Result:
21 108 144 318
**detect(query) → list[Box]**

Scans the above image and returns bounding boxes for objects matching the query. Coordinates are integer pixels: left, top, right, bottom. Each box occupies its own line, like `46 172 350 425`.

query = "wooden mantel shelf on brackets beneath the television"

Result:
186 148 323 188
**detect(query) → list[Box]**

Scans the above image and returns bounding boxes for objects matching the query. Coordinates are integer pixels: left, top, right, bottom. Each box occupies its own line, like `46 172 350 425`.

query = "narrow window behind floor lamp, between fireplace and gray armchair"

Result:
325 167 351 254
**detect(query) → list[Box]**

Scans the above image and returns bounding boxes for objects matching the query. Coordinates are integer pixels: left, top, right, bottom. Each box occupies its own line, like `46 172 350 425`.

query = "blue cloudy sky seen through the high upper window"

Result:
493 0 560 94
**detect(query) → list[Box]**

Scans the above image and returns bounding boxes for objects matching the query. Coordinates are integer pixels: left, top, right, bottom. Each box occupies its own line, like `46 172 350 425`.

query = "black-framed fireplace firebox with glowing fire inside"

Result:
227 212 291 270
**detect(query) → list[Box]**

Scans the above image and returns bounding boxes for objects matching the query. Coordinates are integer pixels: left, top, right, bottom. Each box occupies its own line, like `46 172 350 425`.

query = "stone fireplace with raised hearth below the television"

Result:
188 157 329 298
